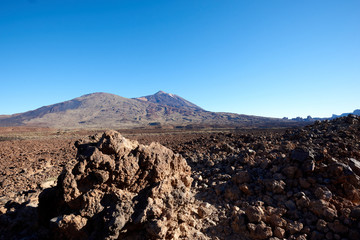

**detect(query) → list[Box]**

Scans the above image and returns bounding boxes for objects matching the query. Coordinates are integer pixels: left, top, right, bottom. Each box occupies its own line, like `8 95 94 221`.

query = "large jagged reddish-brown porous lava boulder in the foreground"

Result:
39 131 205 239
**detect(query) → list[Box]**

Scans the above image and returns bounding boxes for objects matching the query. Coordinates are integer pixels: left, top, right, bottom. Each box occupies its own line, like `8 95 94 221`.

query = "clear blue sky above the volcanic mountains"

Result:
0 0 360 117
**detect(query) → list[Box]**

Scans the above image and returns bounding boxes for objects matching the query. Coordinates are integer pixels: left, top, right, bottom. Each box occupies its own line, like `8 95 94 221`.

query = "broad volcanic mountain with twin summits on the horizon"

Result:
0 91 293 128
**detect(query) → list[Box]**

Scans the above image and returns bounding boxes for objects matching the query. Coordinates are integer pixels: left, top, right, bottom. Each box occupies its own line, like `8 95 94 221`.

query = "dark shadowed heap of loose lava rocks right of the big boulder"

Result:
176 116 360 240
